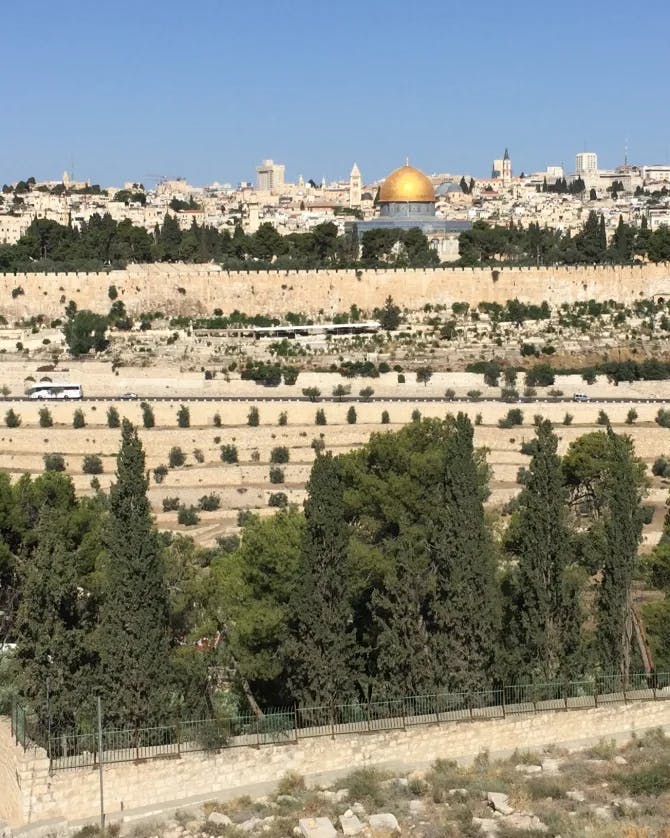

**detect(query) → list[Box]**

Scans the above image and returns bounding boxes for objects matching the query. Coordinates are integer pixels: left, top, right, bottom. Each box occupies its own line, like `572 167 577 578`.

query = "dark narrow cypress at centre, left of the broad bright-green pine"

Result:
287 452 360 707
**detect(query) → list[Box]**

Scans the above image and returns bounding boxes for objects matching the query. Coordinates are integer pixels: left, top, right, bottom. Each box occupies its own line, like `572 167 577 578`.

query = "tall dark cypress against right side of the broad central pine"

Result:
429 413 499 690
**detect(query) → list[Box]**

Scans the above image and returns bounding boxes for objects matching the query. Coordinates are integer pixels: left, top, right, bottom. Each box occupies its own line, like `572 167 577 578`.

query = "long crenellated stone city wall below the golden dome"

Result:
0 264 670 322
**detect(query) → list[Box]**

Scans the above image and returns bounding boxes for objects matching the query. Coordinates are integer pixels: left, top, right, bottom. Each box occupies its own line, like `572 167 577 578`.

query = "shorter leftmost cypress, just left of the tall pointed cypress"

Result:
16 507 94 734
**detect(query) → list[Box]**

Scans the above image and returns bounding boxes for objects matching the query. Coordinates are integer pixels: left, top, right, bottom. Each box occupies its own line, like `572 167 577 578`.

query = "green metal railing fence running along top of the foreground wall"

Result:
11 672 670 771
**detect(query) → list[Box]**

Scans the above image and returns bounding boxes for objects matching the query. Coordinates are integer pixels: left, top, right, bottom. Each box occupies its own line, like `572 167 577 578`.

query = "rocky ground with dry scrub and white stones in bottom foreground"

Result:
75 731 670 838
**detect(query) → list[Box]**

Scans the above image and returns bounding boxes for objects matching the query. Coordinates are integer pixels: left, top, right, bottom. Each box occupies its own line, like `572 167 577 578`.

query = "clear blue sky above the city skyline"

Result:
0 0 670 185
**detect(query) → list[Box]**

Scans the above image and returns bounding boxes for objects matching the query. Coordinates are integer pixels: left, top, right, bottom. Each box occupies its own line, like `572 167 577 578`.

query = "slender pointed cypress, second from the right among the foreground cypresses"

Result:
508 420 579 681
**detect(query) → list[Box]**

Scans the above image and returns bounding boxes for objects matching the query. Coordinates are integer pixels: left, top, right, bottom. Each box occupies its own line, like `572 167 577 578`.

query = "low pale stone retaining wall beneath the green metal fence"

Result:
0 700 670 826
